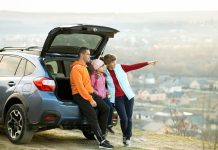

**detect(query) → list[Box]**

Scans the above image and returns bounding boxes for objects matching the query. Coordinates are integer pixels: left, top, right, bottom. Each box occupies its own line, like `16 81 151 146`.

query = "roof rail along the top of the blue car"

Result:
0 46 41 52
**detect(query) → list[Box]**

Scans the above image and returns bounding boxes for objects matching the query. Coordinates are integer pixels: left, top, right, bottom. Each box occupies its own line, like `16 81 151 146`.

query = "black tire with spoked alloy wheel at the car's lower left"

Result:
5 104 34 144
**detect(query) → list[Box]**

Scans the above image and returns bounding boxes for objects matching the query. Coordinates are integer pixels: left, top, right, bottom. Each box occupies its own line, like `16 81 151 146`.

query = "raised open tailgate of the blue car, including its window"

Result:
41 24 119 58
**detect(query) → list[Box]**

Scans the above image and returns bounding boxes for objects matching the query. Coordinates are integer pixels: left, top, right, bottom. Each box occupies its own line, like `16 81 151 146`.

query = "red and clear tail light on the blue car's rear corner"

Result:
33 77 55 92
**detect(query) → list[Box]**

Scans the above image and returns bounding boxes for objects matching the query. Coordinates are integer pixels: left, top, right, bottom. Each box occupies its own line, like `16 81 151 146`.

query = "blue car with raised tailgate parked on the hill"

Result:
0 24 119 144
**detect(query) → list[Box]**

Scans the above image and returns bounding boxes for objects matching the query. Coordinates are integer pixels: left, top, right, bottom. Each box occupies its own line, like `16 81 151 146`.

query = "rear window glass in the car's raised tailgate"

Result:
49 33 102 54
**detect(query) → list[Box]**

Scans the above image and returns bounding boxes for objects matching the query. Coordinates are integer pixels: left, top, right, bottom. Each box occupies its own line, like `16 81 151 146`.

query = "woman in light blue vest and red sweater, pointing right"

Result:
103 54 157 146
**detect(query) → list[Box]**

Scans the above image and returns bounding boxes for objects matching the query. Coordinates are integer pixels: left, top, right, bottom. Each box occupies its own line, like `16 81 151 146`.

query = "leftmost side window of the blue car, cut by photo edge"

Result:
0 56 21 76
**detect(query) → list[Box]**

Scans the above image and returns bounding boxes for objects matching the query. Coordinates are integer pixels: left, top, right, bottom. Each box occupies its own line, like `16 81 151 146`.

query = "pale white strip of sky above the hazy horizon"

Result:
0 0 218 13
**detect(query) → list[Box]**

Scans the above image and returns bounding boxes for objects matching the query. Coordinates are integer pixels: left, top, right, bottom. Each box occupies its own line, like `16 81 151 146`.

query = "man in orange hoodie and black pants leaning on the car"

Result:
70 47 113 149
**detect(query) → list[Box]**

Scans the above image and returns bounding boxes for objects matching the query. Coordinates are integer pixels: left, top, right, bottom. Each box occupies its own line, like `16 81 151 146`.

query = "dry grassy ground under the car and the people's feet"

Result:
0 127 213 150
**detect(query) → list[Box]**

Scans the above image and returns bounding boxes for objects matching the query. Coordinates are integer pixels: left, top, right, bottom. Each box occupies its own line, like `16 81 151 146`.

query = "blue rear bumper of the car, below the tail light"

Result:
28 92 86 126
